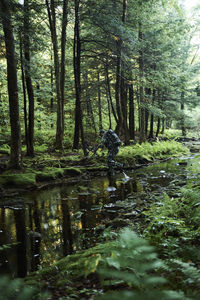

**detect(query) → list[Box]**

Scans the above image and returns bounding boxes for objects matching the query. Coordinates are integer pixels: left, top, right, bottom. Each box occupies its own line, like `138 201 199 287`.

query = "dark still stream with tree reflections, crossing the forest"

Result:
0 154 199 277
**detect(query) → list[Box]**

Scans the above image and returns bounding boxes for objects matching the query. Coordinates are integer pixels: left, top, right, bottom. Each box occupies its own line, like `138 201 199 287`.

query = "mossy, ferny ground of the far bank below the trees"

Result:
0 138 200 197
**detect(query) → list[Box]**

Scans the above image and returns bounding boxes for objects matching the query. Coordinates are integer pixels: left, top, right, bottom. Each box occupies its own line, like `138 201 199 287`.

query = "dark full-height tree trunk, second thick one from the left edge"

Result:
24 0 34 156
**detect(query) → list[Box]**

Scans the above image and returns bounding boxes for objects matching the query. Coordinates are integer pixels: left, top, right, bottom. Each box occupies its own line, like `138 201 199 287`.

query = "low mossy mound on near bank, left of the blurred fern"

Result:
25 242 114 299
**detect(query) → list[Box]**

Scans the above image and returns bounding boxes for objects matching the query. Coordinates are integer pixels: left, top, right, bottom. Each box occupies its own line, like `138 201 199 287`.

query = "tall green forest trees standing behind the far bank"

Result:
0 0 199 168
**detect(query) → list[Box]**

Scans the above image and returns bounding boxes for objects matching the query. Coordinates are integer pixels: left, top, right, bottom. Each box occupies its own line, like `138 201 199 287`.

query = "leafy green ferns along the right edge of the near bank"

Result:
143 188 200 299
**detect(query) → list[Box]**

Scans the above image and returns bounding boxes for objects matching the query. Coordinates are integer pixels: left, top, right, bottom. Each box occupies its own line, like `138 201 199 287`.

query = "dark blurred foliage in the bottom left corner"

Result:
0 277 49 300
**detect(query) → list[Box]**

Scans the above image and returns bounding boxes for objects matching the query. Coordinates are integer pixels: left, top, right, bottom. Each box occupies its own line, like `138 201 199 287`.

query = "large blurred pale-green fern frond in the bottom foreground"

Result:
97 228 187 300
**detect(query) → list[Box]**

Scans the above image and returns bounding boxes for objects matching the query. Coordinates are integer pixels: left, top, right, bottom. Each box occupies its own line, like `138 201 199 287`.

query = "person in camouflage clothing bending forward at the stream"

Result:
94 129 123 175
